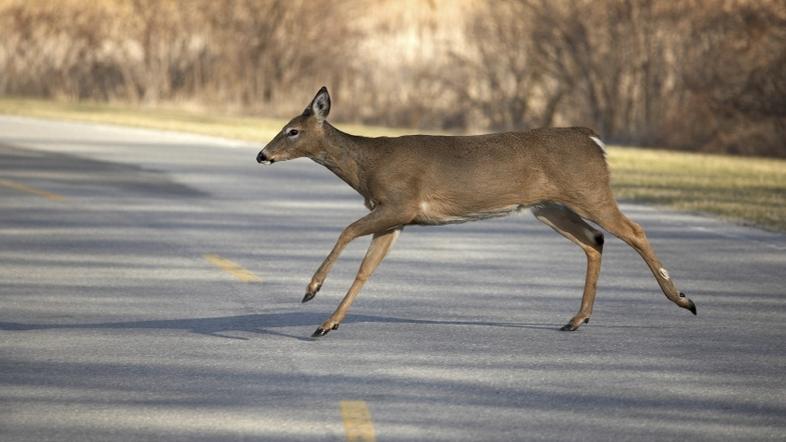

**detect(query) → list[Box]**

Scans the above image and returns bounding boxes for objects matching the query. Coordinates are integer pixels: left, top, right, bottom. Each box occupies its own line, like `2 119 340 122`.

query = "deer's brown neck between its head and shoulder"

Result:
312 122 373 197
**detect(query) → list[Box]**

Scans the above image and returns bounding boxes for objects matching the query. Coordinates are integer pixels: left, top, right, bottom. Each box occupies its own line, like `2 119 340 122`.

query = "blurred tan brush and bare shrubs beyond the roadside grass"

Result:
0 0 786 159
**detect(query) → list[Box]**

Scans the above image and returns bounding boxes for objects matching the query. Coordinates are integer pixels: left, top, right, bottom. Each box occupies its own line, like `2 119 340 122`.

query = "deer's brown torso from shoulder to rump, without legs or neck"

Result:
369 128 608 223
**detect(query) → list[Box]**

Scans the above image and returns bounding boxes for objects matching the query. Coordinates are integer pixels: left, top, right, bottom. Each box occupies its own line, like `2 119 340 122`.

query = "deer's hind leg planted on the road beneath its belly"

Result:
532 204 603 331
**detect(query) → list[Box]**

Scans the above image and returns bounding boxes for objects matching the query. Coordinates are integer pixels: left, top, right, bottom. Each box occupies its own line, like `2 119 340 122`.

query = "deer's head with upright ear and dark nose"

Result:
257 86 330 164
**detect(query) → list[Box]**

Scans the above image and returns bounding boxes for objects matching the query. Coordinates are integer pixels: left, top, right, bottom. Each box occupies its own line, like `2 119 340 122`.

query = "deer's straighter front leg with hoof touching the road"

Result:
312 228 401 337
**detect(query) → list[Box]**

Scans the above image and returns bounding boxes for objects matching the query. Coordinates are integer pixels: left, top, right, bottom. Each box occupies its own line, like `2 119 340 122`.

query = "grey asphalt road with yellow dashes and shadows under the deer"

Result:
0 117 786 441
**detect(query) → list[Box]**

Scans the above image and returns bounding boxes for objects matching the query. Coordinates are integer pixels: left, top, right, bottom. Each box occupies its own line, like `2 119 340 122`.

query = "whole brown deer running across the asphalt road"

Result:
257 86 696 338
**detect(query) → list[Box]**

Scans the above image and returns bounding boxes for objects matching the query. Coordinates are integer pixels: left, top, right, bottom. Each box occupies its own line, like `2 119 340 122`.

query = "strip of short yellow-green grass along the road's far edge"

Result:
0 97 786 232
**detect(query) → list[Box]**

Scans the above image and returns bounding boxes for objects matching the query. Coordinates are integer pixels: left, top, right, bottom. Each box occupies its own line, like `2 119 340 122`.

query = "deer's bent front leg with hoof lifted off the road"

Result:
302 207 406 302
